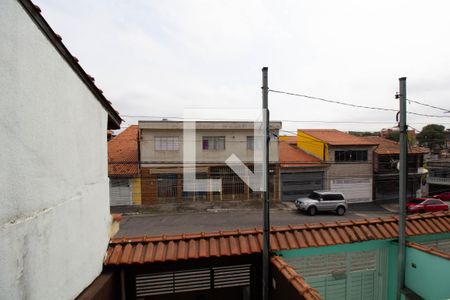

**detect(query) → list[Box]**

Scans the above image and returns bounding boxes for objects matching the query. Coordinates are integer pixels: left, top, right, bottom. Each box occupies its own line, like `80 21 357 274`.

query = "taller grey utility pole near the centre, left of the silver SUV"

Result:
262 67 270 300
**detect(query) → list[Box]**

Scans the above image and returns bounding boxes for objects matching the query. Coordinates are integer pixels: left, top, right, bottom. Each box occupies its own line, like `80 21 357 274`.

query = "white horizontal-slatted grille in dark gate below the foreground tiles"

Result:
136 264 251 297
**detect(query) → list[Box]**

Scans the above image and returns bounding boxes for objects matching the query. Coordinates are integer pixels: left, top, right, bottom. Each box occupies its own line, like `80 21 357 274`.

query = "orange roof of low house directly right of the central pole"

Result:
278 141 322 168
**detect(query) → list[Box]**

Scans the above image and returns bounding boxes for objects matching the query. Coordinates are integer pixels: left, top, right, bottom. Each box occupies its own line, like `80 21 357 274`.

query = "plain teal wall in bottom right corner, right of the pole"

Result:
405 247 450 299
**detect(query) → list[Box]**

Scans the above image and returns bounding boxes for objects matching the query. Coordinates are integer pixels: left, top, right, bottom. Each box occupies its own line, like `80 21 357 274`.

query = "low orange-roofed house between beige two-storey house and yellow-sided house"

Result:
278 136 327 201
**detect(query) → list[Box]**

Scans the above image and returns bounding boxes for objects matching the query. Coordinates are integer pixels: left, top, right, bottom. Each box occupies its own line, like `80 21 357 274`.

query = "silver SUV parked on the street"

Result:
294 191 348 216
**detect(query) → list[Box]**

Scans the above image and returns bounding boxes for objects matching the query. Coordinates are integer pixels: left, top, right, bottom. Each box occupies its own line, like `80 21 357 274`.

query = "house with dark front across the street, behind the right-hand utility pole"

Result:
364 136 429 201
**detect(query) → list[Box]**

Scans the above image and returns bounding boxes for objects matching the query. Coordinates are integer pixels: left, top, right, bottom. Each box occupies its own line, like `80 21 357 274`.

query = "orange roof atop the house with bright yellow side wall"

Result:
298 129 377 146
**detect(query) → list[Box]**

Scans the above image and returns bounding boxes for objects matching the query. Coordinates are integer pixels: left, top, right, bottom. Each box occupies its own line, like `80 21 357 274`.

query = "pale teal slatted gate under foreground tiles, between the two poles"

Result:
287 249 388 300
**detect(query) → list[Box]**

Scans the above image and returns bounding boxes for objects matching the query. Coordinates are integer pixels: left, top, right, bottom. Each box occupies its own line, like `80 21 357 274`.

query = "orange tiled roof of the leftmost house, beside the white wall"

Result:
108 125 139 176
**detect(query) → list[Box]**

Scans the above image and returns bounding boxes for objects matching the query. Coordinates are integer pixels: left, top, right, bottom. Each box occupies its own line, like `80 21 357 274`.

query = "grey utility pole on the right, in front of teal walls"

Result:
397 77 408 300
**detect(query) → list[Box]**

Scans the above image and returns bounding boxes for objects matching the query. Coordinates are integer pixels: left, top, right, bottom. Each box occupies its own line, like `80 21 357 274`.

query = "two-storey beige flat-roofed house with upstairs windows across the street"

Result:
139 121 281 204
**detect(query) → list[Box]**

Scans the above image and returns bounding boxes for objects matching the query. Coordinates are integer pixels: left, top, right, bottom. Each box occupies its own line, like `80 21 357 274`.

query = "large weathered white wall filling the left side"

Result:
0 0 110 299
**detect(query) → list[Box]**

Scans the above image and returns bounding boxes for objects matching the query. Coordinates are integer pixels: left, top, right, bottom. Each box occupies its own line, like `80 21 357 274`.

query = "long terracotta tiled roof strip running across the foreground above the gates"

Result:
104 212 450 265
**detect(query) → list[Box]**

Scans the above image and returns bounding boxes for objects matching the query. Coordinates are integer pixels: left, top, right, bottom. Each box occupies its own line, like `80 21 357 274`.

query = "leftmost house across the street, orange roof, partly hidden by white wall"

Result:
108 125 141 206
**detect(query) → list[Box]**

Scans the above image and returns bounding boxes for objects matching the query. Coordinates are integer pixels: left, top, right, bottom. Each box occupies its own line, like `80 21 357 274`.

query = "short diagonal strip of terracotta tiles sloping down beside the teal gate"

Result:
271 256 322 300
